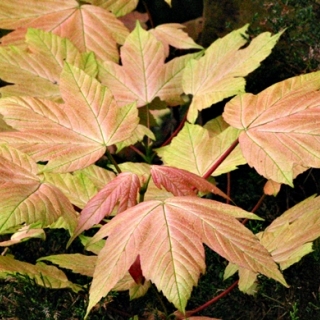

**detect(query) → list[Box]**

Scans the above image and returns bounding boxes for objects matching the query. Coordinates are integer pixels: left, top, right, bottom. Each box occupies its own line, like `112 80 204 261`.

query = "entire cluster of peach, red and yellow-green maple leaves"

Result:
0 0 320 319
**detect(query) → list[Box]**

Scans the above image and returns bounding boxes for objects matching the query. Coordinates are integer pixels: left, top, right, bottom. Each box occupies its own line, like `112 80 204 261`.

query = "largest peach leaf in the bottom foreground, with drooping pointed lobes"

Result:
87 197 286 312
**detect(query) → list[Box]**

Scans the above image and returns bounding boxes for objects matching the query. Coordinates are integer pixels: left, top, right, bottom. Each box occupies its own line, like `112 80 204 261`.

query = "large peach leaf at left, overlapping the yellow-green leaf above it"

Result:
0 64 139 172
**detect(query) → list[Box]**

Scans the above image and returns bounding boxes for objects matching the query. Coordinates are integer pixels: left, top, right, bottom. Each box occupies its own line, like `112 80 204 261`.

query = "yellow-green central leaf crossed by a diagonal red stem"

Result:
156 123 246 176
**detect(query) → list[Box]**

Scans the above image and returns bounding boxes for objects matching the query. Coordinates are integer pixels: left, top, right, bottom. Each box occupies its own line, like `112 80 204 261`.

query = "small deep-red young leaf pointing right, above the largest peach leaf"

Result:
151 165 230 200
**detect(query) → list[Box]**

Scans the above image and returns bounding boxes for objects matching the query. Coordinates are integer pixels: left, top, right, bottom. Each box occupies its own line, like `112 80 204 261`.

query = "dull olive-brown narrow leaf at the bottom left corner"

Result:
0 256 82 292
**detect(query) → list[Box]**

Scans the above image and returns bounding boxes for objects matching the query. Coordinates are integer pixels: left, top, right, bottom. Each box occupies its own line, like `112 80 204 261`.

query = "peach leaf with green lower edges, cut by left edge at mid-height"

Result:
0 145 76 233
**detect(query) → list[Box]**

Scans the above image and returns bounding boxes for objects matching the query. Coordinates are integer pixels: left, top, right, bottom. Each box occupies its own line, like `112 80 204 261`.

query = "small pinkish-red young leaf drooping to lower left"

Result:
68 172 140 244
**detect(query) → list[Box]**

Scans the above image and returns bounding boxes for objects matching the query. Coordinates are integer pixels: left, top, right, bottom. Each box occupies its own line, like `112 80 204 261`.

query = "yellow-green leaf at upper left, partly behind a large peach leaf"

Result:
0 28 98 100
